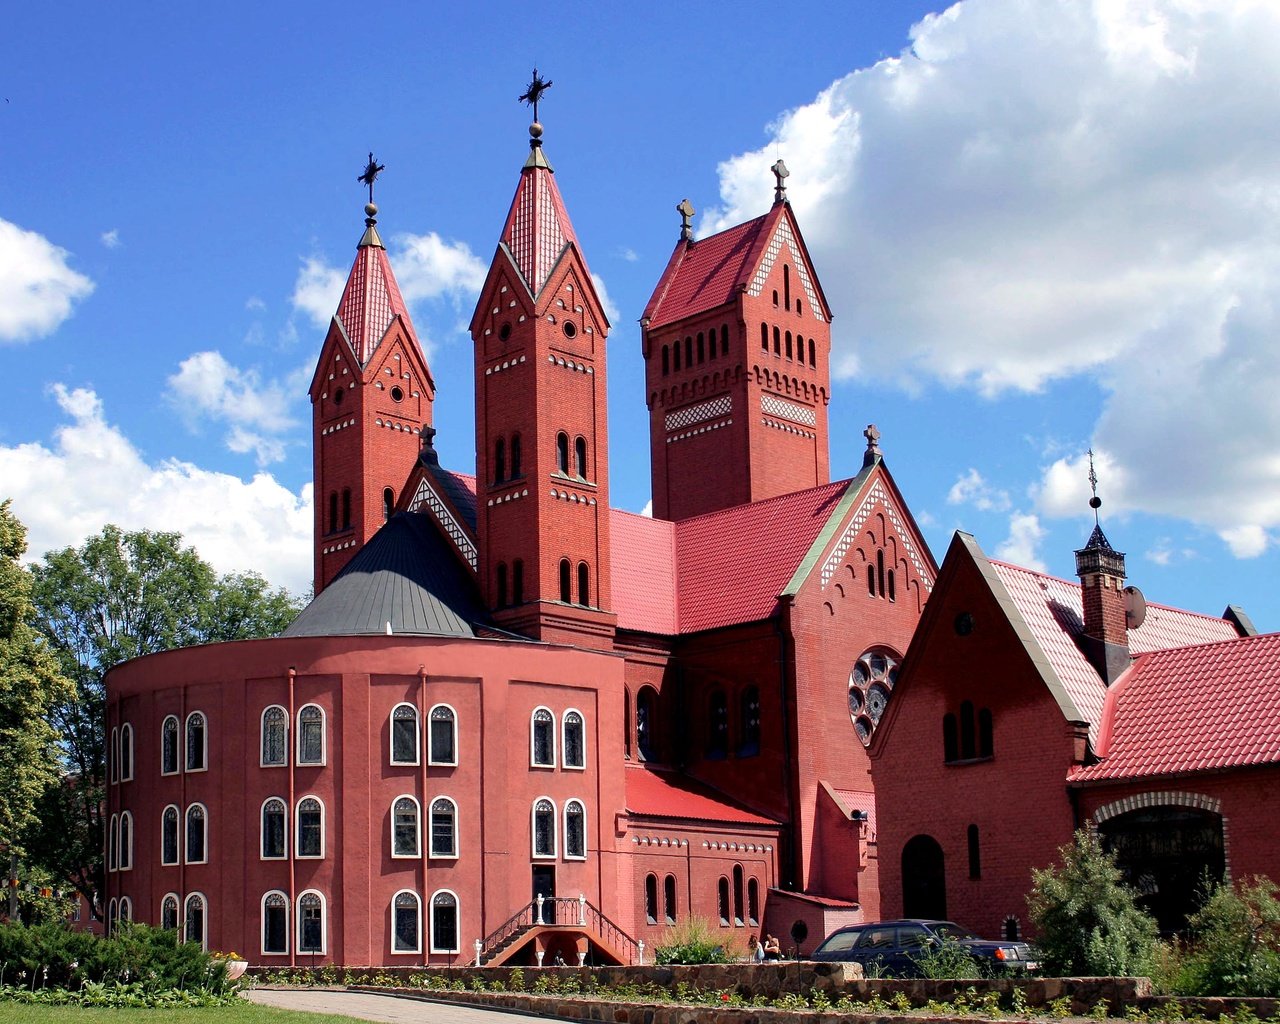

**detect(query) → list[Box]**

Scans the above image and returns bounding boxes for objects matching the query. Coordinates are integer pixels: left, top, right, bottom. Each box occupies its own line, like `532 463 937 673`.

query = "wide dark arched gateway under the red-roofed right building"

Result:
1098 806 1226 932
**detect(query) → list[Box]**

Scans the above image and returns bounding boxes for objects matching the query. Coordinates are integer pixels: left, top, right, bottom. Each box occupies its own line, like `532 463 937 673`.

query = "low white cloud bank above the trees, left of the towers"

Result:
0 384 312 594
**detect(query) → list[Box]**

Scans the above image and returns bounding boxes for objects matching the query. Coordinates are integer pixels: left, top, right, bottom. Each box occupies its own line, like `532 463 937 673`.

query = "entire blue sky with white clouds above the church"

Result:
0 0 1280 630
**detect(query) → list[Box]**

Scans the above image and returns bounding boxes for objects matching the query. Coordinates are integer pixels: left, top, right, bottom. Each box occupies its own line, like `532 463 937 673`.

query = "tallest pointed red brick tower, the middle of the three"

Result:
471 83 616 649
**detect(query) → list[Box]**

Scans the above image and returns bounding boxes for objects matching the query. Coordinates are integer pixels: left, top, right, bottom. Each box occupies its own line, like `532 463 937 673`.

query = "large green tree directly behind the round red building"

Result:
28 526 300 914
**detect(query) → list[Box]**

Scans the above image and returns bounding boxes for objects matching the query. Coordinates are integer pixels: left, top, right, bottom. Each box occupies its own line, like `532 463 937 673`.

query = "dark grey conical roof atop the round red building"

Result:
282 512 485 636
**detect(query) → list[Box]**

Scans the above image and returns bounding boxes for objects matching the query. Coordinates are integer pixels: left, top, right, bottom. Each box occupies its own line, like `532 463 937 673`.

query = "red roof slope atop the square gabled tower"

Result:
641 211 782 328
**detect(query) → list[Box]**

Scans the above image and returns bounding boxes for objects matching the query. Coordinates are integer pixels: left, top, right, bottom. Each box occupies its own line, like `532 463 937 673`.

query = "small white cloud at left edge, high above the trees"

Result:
0 218 93 343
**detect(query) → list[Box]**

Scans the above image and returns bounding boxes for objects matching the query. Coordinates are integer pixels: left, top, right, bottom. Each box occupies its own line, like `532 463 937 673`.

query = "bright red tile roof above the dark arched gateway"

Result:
1070 634 1280 782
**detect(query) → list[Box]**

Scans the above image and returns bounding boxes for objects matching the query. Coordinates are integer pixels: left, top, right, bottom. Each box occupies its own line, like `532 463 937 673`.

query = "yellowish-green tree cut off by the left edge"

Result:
0 500 73 874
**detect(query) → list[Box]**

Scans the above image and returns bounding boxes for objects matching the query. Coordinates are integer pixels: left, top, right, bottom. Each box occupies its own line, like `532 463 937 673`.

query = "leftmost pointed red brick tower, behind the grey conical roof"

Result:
311 154 435 594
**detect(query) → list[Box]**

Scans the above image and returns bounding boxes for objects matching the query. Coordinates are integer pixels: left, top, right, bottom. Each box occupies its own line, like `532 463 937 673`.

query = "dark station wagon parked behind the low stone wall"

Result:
809 919 1038 978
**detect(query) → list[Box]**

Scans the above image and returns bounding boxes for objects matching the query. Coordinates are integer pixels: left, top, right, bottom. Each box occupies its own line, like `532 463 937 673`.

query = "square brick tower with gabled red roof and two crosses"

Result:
640 160 831 520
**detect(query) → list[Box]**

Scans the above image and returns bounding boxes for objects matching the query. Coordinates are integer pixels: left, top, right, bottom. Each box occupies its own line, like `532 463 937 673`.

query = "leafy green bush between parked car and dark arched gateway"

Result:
1027 828 1156 975
